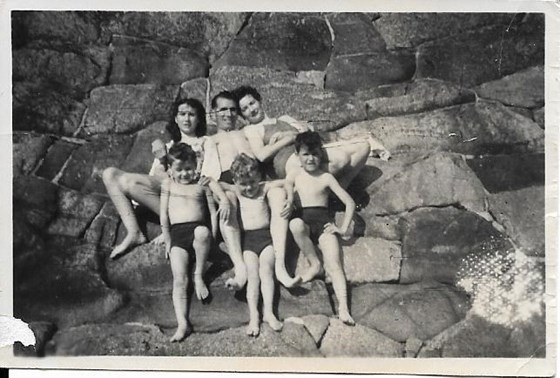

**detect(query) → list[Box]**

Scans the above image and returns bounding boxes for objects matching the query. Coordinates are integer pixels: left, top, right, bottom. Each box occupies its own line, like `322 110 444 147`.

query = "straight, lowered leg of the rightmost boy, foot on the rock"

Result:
319 234 355 325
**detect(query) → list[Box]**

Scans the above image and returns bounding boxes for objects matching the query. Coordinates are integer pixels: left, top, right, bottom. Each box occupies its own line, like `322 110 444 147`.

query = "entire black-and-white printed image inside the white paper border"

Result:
6 1 557 372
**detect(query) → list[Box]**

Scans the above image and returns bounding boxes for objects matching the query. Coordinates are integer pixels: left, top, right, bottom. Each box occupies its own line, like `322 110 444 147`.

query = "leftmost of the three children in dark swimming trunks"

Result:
160 143 230 342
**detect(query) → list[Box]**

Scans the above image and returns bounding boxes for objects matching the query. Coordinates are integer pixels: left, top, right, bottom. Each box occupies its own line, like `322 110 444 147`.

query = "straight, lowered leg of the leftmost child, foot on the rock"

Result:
169 247 191 342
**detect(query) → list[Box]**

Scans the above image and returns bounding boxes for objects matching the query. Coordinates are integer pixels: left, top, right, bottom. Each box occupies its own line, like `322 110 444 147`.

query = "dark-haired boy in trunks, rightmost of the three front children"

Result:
284 131 356 325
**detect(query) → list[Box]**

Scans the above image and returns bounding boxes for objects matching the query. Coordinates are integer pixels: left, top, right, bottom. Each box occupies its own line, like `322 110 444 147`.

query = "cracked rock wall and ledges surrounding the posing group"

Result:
11 11 544 360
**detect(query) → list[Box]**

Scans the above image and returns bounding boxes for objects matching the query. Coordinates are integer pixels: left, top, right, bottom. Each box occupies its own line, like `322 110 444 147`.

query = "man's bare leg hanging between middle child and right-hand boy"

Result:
268 188 301 287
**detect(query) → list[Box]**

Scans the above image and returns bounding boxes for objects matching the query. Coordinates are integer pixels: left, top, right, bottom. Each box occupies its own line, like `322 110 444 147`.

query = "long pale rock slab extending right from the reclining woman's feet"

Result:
339 102 544 154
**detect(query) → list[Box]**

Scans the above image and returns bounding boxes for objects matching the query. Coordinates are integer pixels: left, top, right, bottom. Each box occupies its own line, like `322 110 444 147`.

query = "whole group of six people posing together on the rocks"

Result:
103 86 389 341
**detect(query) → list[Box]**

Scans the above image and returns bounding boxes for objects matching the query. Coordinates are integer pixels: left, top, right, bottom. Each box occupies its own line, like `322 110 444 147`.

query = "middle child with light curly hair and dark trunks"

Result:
221 153 283 336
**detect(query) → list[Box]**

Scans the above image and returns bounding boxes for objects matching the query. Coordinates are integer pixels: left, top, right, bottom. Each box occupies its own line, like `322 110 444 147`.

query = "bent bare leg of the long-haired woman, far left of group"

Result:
102 168 161 259
